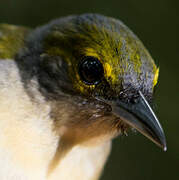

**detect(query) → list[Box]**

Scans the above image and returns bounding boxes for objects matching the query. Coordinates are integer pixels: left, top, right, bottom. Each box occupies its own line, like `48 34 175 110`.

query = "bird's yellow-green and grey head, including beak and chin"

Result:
17 14 166 149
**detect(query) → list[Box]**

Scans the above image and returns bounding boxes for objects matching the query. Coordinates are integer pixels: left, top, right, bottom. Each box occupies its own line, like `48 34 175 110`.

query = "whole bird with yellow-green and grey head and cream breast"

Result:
0 13 167 180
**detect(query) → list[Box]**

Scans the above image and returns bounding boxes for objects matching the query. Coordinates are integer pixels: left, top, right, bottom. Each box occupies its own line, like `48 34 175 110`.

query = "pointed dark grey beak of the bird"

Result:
112 91 167 151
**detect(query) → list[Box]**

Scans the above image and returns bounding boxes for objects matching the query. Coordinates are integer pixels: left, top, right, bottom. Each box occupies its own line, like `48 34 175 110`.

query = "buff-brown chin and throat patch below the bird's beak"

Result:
51 95 129 146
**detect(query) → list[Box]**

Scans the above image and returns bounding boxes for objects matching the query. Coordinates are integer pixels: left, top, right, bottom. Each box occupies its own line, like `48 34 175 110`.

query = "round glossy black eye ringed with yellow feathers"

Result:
79 56 104 85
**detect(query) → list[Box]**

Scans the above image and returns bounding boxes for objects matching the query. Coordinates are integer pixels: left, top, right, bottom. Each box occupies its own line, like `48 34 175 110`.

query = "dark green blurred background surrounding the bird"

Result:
0 0 179 180
